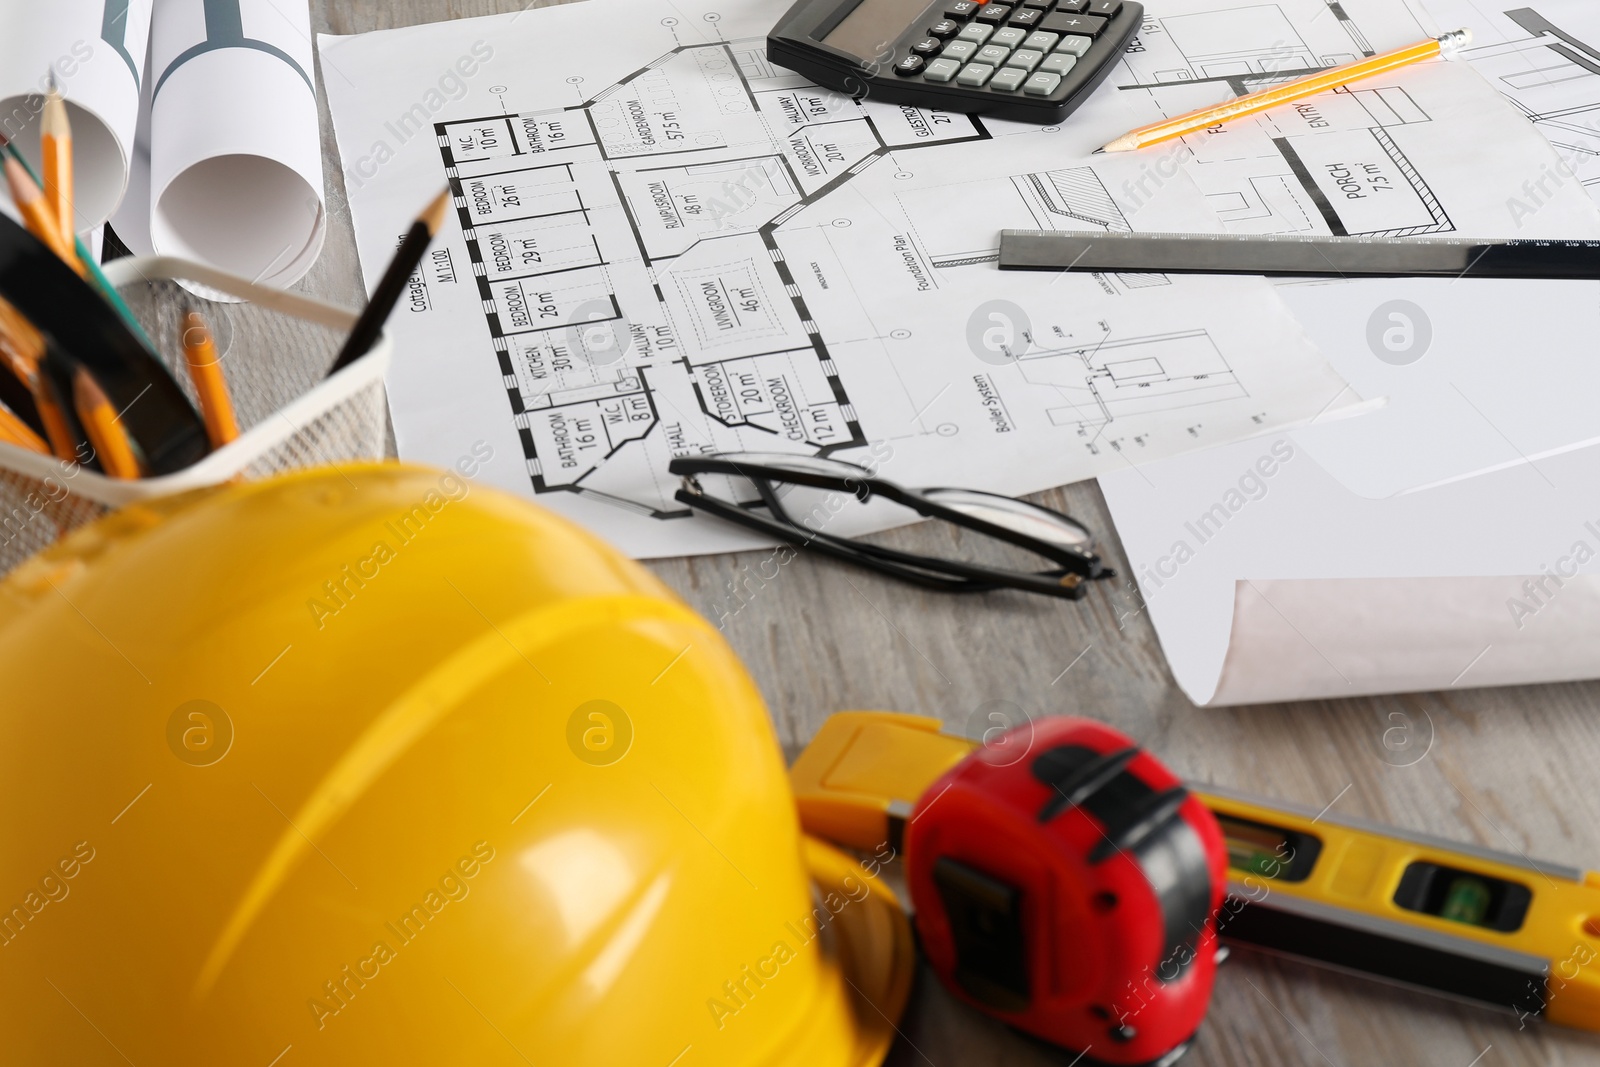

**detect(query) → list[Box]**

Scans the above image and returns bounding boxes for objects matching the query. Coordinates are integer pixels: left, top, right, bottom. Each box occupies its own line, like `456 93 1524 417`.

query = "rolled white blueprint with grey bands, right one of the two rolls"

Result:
149 0 328 286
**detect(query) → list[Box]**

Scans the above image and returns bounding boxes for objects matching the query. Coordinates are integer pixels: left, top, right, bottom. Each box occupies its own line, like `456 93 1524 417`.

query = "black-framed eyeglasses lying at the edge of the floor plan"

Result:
667 453 1115 600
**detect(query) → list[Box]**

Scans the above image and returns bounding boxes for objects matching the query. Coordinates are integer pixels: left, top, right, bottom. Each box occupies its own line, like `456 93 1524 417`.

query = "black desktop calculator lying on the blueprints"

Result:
766 0 1144 123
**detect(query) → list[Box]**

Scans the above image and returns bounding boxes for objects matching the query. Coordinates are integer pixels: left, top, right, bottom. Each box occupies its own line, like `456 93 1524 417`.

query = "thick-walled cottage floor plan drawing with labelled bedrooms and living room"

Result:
435 42 998 518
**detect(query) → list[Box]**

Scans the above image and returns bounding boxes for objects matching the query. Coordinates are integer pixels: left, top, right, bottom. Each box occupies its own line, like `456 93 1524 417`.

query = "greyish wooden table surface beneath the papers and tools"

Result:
288 0 1600 1067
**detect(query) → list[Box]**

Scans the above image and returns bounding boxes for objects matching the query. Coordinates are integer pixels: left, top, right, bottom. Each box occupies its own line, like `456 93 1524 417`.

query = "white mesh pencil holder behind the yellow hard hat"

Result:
0 256 390 576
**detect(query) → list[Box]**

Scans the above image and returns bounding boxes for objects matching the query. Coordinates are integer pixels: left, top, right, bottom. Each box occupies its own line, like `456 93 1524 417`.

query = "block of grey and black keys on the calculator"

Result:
894 0 1138 108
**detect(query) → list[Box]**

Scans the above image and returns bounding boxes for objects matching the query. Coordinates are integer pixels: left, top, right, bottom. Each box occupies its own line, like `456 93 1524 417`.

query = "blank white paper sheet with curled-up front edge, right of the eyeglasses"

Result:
1099 435 1600 704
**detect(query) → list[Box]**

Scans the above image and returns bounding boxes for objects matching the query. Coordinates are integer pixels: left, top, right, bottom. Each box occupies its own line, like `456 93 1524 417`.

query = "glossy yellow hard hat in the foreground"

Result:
0 454 912 1067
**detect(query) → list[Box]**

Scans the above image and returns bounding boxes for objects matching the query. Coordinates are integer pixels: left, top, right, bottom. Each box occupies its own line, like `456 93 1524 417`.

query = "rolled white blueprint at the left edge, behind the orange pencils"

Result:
0 0 150 234
